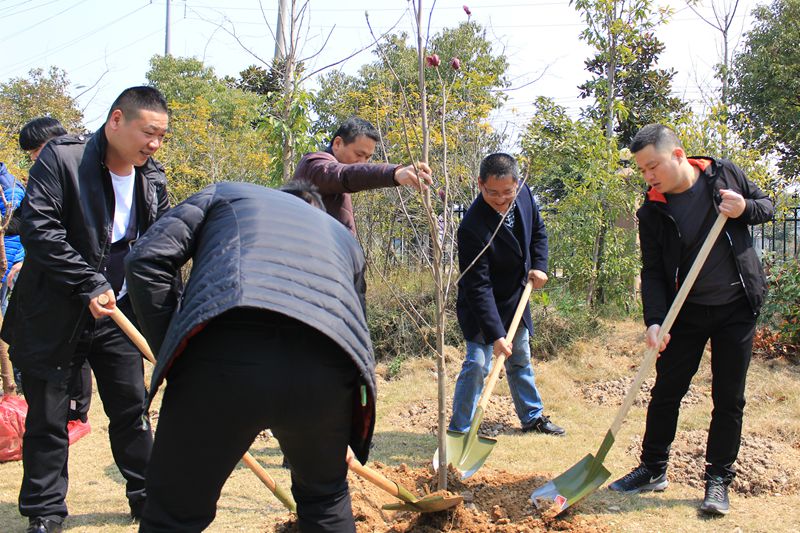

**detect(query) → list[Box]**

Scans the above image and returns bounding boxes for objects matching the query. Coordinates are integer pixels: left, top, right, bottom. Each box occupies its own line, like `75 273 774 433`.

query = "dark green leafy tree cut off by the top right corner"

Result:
731 0 800 180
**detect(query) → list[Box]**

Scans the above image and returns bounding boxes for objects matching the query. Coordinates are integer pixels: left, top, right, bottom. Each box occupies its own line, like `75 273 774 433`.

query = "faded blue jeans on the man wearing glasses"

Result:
448 327 543 431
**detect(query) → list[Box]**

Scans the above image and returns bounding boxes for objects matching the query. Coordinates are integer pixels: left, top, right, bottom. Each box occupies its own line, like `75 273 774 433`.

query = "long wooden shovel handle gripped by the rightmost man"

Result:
609 213 728 437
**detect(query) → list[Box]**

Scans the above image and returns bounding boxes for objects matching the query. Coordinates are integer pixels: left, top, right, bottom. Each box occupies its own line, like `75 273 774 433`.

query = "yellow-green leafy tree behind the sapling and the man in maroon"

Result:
313 22 508 264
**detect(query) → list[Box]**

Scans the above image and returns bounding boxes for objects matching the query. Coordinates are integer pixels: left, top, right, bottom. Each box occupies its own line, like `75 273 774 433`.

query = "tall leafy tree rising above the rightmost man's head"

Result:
574 0 686 146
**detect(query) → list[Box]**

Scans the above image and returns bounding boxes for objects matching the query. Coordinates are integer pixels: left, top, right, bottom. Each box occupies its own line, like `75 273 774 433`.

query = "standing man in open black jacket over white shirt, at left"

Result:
2 87 169 533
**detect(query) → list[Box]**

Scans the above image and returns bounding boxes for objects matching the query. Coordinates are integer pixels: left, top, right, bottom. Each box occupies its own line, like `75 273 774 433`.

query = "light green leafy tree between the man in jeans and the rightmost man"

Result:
520 98 643 307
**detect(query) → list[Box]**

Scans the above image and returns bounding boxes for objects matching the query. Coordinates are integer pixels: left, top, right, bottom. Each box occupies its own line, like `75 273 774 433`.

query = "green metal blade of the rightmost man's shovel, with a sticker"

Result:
531 454 611 513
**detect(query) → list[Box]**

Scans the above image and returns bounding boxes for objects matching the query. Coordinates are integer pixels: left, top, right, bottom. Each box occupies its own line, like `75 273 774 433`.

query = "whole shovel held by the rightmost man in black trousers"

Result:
531 213 728 513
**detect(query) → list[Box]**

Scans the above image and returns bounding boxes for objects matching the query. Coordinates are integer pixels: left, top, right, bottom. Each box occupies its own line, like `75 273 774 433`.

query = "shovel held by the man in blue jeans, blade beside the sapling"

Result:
433 280 533 479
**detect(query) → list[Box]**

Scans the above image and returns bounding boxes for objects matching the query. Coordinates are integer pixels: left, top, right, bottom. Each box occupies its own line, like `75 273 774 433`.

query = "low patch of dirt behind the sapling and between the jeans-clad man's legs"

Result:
390 395 521 437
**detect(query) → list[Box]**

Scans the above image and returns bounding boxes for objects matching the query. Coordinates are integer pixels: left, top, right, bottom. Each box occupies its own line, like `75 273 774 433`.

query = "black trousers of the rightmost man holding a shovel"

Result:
641 298 756 480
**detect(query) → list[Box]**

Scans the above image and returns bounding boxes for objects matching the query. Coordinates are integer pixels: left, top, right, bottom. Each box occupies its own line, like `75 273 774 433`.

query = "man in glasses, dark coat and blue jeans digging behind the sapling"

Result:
449 153 565 435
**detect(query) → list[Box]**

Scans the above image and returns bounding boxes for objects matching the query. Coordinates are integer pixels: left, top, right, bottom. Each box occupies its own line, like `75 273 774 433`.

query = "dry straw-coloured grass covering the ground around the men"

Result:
0 321 800 533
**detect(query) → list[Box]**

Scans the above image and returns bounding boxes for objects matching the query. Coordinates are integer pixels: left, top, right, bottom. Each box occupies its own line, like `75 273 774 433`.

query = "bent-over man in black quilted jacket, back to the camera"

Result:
126 183 375 532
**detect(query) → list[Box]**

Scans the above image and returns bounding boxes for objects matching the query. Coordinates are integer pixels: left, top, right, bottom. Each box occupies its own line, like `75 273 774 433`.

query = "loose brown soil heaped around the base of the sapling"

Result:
276 462 608 533
